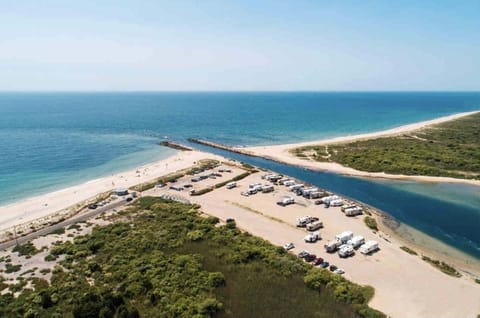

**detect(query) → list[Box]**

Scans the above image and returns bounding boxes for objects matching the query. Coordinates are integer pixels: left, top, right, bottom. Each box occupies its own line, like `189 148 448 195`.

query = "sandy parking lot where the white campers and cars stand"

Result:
157 173 480 318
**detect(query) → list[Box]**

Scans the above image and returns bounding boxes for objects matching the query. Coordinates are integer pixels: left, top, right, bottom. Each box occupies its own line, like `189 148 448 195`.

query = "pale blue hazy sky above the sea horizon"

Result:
0 0 480 91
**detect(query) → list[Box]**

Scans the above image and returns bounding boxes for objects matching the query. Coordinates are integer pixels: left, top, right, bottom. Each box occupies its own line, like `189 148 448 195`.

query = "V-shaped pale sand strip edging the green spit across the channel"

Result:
244 111 480 185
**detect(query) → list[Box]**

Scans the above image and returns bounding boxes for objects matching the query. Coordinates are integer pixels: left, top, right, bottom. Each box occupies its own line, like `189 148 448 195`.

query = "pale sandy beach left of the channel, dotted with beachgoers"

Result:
0 151 223 231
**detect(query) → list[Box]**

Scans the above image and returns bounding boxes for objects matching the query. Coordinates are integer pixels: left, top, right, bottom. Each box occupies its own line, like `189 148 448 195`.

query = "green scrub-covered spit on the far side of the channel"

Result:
292 113 480 180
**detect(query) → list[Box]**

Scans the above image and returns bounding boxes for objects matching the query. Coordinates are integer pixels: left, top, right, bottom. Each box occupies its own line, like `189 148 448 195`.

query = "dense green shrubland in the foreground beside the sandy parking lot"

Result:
0 197 385 317
